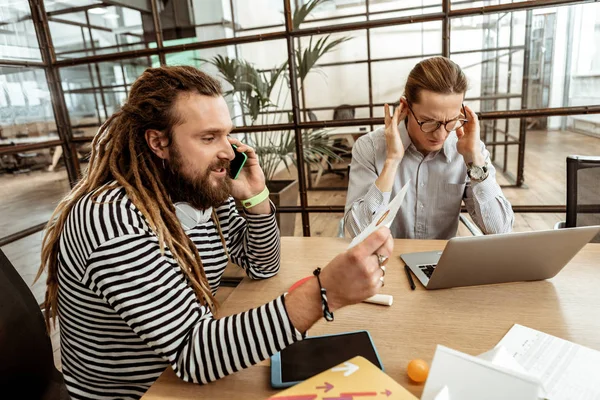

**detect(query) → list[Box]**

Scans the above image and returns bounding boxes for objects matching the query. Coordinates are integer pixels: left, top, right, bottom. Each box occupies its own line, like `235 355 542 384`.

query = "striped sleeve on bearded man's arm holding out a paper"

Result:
82 234 302 383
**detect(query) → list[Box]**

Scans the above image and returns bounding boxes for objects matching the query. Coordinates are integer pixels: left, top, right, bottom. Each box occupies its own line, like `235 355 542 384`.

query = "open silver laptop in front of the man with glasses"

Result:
400 226 600 289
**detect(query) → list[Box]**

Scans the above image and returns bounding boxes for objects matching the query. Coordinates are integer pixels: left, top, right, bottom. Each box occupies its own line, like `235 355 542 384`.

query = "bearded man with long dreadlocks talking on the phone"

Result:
38 66 393 399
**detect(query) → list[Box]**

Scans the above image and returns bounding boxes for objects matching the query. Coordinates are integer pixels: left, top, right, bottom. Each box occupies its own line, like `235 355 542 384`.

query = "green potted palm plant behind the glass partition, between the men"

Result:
202 0 351 236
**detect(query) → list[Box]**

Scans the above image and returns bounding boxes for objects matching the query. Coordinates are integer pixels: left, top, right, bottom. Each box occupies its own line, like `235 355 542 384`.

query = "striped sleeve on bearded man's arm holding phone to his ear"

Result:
227 199 281 279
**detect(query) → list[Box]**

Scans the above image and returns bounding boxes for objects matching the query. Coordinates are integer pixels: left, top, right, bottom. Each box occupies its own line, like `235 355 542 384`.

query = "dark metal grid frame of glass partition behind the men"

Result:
0 0 600 244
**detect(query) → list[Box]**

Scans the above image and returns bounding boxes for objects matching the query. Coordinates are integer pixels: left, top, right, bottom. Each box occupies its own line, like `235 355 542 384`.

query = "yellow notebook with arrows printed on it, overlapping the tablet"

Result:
268 356 417 400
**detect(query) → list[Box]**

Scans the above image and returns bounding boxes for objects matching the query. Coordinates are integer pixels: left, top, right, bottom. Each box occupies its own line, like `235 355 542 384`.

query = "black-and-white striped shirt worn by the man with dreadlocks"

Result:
58 187 302 399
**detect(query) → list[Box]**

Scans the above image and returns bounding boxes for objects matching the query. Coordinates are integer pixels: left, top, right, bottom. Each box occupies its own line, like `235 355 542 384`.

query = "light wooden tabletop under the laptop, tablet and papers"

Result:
143 237 600 400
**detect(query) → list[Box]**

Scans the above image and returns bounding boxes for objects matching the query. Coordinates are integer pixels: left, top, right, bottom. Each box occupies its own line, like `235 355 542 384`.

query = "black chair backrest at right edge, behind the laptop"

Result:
565 156 600 243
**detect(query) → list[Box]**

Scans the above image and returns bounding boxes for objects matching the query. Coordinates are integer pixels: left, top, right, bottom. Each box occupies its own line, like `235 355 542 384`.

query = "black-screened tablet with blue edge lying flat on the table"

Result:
271 331 383 388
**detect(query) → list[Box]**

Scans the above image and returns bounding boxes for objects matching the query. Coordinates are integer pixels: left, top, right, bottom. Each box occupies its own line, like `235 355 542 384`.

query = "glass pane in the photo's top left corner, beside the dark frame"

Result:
0 0 42 61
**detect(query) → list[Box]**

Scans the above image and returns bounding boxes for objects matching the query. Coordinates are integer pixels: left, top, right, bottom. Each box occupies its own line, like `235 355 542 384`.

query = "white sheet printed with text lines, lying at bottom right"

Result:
497 324 600 400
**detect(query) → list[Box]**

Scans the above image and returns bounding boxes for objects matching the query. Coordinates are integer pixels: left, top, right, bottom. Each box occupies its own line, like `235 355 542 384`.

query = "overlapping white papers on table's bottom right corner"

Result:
422 324 600 400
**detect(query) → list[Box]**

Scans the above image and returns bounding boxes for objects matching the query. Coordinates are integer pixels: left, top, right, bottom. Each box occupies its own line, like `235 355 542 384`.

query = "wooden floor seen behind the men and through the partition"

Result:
0 126 600 366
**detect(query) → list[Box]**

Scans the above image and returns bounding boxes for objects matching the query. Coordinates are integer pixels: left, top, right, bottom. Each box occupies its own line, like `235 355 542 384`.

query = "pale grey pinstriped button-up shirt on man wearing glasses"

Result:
344 123 514 239
